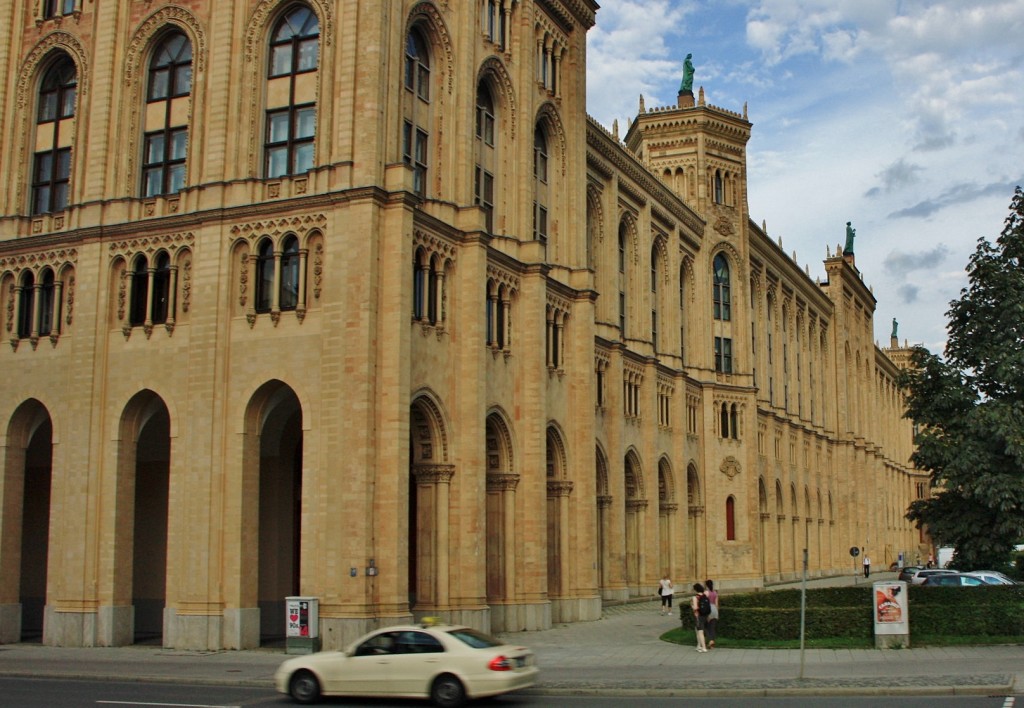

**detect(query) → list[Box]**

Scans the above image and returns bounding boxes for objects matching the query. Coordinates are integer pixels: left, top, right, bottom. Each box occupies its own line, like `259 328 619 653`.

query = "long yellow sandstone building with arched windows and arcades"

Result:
0 0 927 649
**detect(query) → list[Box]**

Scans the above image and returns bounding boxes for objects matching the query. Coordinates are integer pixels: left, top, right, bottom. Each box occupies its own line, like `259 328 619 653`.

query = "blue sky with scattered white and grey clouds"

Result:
587 0 1024 352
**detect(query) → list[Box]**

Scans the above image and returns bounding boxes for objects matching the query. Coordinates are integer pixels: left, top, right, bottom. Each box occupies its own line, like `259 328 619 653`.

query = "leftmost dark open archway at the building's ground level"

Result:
0 399 53 643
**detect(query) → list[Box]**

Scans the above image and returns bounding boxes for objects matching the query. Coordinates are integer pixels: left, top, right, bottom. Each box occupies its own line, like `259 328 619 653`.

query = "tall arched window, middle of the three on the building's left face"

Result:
142 32 193 197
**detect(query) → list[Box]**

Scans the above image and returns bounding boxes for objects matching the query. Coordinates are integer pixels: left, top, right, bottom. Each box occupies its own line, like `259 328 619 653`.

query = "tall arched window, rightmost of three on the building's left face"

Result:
264 5 319 177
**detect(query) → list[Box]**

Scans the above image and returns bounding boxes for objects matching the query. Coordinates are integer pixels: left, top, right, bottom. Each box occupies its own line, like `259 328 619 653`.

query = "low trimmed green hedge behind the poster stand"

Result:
680 585 1024 640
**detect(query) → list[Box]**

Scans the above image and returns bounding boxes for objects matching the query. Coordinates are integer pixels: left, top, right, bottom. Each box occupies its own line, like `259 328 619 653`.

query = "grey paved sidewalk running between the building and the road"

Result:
0 574 1024 696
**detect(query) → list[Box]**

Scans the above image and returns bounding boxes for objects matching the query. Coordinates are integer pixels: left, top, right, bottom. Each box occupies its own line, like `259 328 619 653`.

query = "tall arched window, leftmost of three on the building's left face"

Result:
32 55 78 214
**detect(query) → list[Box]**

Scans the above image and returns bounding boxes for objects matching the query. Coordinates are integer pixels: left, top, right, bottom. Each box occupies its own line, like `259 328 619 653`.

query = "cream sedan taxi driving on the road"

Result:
274 622 539 708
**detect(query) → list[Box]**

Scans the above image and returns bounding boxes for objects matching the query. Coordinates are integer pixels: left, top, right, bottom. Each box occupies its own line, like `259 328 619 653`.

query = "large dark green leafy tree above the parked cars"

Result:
901 186 1024 570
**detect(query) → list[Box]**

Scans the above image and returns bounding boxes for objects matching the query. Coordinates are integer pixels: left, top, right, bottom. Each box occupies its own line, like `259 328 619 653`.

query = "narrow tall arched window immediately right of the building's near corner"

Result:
401 28 430 197
